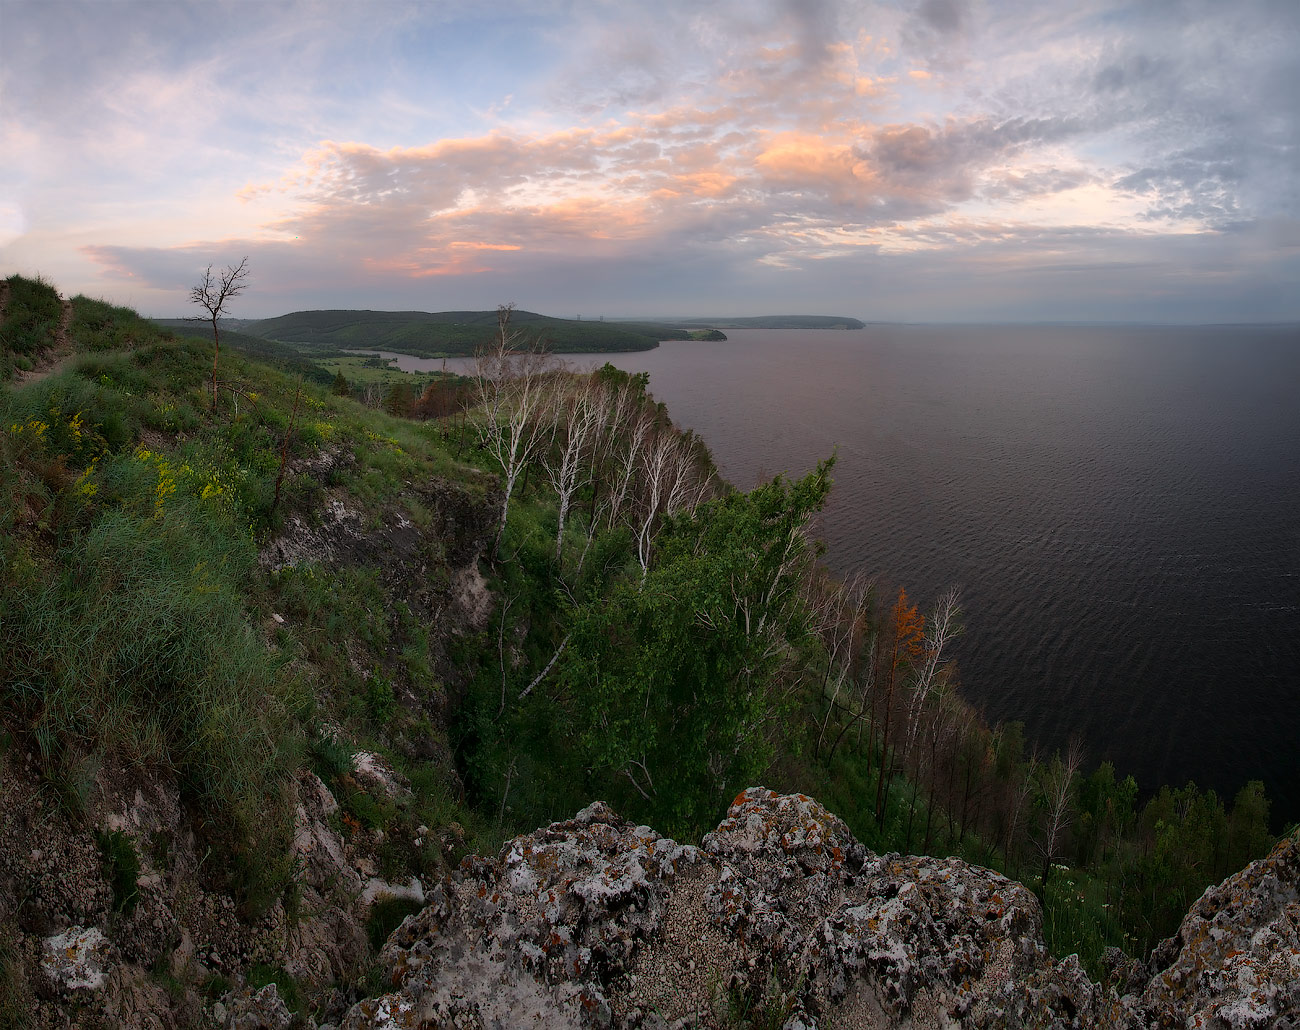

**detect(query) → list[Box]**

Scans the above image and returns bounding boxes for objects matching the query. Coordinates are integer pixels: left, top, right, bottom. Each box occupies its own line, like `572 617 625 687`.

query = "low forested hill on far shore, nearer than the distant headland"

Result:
243 311 689 358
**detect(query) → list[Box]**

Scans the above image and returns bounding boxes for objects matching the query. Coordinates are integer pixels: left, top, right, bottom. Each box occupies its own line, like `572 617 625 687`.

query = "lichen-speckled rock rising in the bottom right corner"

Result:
1128 838 1300 1030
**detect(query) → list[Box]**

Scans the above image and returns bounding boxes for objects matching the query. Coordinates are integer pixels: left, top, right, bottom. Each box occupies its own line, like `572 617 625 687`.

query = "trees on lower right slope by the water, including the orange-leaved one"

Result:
807 567 1273 958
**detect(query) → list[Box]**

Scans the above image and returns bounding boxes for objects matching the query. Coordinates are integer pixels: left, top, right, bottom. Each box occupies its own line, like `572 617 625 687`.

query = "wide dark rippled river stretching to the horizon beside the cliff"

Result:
364 325 1300 821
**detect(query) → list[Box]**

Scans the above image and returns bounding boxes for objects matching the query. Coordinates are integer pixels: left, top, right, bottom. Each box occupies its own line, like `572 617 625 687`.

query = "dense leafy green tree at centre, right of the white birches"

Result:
559 462 831 832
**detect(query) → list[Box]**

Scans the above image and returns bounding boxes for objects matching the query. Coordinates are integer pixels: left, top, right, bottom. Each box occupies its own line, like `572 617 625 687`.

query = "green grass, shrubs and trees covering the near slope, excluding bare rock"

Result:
0 273 1271 988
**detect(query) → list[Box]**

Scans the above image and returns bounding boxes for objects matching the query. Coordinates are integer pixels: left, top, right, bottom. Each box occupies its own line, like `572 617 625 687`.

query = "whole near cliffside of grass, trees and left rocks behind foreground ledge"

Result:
0 277 1274 1025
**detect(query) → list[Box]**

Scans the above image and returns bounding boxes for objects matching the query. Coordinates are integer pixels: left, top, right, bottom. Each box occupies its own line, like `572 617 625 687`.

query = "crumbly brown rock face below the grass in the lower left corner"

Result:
0 752 395 1029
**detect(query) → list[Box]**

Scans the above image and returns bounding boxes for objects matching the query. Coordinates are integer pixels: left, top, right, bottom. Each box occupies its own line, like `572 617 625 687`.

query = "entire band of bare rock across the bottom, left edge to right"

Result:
0 769 1300 1030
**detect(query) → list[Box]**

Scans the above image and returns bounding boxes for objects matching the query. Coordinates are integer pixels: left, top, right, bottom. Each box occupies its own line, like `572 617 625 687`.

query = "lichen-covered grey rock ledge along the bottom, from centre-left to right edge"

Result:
343 788 1300 1030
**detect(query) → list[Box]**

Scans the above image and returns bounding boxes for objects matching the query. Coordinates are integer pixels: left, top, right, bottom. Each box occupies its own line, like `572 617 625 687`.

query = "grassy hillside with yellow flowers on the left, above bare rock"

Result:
0 277 493 904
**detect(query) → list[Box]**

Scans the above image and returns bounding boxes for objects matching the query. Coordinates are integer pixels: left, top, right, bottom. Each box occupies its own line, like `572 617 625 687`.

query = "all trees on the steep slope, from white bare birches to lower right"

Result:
371 299 1271 972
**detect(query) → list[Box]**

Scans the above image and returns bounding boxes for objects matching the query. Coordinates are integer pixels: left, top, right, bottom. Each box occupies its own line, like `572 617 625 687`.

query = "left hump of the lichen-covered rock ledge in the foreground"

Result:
343 802 699 1027
